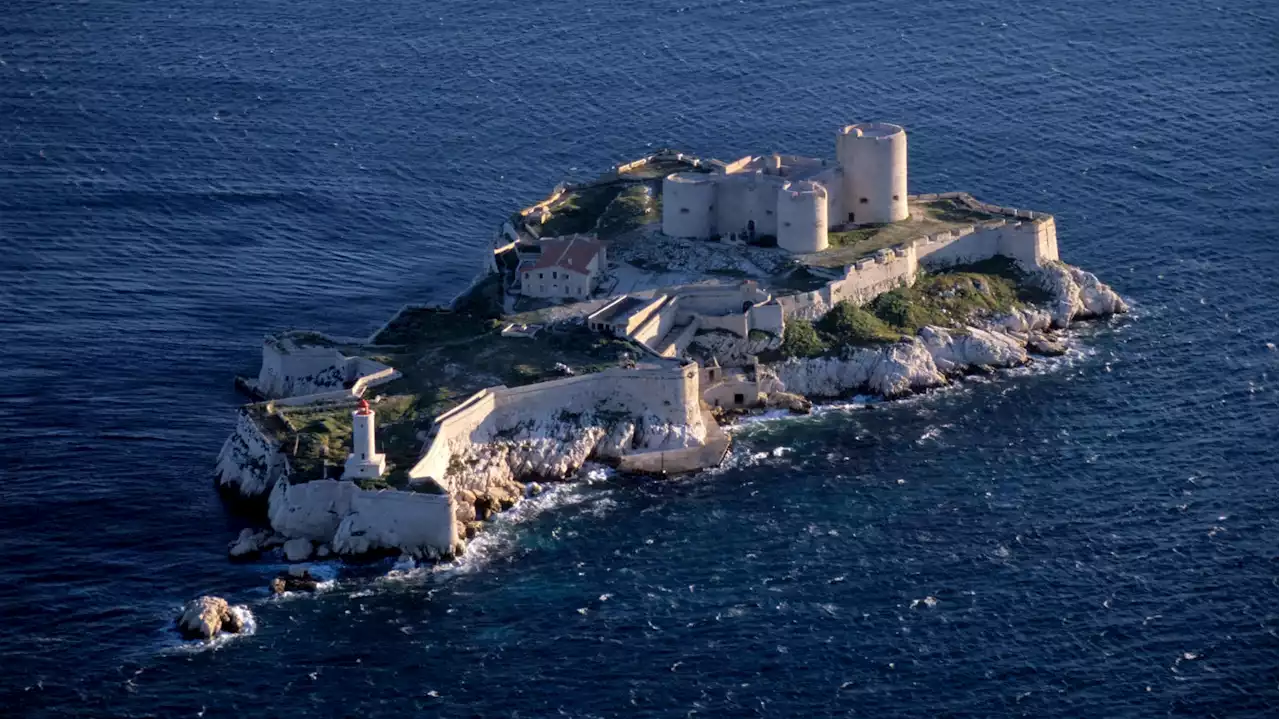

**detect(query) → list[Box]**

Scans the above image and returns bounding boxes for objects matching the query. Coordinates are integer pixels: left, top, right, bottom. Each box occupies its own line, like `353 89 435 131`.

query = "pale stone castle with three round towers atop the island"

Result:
662 123 908 253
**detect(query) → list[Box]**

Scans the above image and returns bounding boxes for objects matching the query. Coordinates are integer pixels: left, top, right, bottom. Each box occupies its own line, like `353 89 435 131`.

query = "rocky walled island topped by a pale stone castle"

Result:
215 123 1128 562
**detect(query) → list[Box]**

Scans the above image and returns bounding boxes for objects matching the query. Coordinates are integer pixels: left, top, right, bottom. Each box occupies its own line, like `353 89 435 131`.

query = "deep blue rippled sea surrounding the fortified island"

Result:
0 0 1280 718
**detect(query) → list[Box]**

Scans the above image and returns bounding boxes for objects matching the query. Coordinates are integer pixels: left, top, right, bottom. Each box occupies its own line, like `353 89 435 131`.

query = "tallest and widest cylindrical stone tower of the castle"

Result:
836 123 908 224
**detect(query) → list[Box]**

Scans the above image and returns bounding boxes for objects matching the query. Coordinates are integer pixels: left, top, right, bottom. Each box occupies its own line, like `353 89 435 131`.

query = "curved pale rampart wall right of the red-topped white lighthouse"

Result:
408 361 701 491
